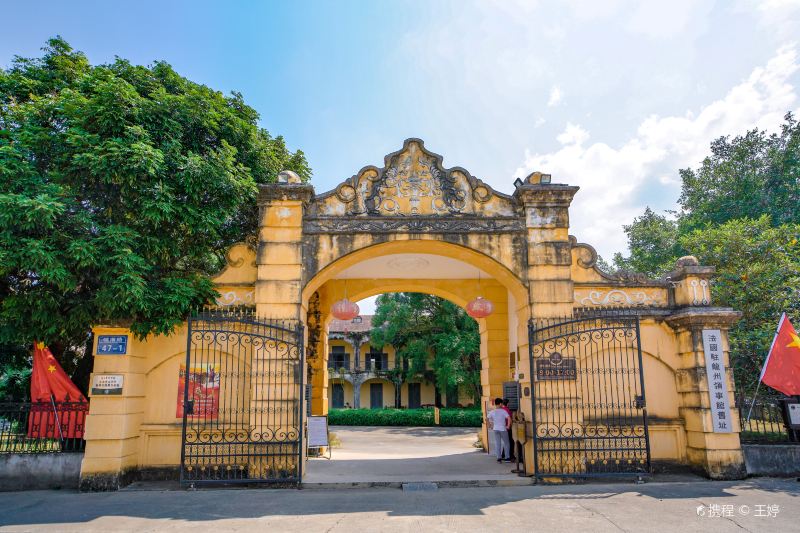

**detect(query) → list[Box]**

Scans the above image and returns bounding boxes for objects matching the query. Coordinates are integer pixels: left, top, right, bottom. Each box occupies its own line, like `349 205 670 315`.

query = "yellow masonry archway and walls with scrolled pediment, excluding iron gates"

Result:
82 139 743 488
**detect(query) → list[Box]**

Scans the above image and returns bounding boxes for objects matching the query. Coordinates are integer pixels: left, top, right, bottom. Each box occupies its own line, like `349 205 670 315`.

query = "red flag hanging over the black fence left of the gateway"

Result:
28 342 86 439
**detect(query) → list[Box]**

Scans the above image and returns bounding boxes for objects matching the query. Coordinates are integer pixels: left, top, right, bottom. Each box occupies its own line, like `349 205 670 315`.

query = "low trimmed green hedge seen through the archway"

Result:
328 408 483 427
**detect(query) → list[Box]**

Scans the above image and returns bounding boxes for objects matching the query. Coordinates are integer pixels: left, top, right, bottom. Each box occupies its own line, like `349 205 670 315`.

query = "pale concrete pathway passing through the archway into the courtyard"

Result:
303 426 520 487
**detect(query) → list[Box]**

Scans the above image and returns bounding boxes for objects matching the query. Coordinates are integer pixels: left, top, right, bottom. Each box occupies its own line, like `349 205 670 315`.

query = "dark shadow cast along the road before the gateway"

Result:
0 479 800 526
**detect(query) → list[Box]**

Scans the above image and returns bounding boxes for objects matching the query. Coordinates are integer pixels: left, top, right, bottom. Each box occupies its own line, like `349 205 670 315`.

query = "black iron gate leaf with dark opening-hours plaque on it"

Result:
528 309 650 477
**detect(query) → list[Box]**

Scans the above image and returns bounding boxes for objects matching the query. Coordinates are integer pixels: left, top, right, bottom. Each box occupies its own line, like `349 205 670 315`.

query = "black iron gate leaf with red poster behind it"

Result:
178 308 305 484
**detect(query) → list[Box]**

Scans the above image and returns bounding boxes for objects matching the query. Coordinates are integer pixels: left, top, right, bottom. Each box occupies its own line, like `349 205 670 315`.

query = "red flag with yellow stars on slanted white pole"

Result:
761 313 800 396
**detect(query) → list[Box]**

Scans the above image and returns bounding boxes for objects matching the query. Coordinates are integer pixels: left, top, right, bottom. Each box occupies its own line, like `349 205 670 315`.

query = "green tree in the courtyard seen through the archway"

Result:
370 293 481 401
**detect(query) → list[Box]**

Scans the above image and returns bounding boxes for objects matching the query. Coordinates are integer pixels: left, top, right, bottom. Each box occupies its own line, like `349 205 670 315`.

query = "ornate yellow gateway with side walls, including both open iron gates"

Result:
81 139 745 489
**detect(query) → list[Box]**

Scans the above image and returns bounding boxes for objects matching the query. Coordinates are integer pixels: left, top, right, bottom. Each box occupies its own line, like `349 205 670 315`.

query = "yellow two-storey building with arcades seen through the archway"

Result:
328 315 472 409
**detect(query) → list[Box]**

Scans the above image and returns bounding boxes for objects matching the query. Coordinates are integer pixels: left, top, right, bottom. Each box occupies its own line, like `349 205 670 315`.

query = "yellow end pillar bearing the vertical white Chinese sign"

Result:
666 257 746 479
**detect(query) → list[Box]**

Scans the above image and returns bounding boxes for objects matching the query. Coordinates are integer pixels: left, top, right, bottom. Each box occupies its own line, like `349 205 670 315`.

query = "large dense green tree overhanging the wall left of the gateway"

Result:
0 38 310 392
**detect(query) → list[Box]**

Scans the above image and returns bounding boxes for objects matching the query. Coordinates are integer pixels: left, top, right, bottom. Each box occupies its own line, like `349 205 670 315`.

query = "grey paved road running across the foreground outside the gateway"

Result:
0 479 800 533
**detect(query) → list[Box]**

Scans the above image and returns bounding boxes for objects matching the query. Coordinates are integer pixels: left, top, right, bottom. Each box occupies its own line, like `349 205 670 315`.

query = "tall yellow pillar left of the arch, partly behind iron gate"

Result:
249 171 314 477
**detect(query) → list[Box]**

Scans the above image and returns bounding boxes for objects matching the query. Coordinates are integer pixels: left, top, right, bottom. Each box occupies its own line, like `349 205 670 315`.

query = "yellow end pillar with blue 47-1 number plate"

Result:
80 326 145 490
